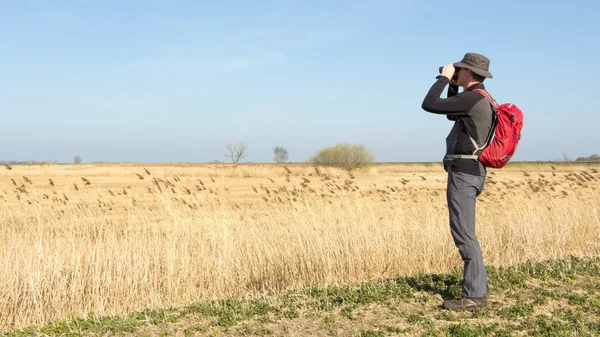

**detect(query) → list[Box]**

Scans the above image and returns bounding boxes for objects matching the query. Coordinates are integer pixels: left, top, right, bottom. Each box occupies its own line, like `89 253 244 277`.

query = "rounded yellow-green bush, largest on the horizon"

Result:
310 144 375 171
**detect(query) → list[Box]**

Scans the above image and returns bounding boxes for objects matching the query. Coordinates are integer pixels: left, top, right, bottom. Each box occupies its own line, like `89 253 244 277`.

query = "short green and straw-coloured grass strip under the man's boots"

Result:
5 257 600 336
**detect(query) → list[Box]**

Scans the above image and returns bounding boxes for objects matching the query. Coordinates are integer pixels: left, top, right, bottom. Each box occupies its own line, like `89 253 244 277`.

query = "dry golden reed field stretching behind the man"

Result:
0 163 600 330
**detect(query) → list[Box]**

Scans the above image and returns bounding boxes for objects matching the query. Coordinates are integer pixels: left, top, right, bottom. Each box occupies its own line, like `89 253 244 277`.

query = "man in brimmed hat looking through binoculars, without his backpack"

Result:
422 53 495 311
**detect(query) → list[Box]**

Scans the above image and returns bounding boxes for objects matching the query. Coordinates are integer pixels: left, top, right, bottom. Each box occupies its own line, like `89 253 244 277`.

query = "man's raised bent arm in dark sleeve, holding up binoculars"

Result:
421 76 469 117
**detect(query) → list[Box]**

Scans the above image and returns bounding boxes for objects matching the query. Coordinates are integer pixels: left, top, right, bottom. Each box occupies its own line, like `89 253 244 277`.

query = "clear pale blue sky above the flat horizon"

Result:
0 0 600 162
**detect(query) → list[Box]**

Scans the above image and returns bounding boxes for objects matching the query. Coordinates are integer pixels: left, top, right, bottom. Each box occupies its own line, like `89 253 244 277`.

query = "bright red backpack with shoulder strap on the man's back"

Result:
473 89 523 168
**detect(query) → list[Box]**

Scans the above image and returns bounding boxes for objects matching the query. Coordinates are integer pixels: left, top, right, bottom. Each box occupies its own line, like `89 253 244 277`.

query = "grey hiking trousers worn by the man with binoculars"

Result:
446 171 488 297
